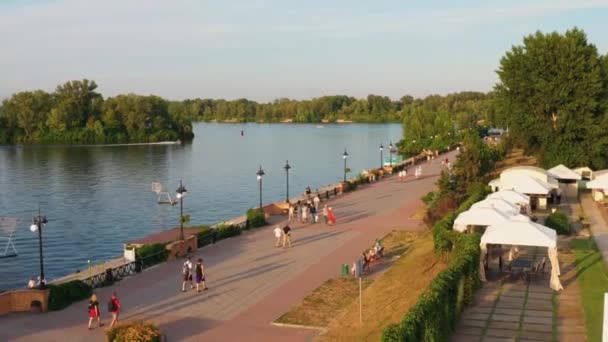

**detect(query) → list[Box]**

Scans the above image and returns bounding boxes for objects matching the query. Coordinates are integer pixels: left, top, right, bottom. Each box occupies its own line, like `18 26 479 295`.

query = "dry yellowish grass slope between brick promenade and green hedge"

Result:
319 231 446 341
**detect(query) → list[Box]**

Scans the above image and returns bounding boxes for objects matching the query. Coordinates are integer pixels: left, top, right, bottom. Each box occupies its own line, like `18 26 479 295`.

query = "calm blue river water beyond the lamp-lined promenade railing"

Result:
0 123 402 289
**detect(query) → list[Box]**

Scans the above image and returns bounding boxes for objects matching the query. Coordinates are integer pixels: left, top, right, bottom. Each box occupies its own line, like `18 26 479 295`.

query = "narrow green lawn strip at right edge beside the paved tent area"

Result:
572 238 608 341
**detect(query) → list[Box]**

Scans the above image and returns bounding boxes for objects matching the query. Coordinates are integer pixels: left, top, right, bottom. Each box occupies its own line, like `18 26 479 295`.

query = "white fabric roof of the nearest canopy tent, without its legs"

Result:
481 217 557 247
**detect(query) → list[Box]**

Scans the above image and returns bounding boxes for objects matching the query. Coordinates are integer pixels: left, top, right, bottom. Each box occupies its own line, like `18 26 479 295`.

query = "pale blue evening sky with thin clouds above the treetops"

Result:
0 0 608 101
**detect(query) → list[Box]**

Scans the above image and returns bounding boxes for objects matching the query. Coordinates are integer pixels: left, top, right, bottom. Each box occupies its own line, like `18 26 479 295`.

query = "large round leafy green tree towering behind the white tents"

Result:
495 28 608 168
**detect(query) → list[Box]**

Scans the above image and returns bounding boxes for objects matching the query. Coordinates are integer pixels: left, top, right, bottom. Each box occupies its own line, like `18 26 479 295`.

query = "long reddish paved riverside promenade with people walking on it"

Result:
0 152 454 342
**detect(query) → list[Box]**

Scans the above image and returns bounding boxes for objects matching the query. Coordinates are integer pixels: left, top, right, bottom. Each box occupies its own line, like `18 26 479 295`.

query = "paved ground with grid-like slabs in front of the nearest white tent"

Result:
451 244 586 342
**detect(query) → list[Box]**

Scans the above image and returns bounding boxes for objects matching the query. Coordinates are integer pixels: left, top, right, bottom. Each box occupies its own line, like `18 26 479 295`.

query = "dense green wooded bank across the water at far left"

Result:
0 79 194 144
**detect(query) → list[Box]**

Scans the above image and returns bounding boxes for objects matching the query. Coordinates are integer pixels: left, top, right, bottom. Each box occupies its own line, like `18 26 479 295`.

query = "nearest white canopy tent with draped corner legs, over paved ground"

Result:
479 218 563 291
